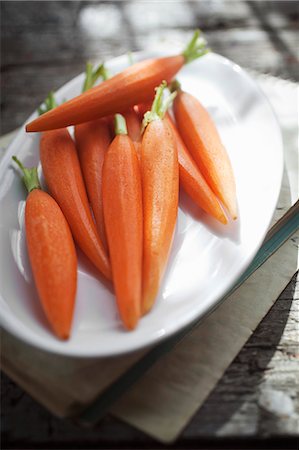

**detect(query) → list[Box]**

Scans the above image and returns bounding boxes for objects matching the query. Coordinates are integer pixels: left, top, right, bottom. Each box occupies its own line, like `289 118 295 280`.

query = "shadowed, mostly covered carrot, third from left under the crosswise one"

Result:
75 119 111 250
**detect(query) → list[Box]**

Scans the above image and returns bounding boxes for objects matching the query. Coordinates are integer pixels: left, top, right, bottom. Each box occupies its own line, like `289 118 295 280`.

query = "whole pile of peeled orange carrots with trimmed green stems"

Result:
14 31 237 339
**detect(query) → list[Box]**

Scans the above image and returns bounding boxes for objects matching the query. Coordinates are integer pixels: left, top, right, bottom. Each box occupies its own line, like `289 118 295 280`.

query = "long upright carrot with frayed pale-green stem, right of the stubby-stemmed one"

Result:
141 82 179 314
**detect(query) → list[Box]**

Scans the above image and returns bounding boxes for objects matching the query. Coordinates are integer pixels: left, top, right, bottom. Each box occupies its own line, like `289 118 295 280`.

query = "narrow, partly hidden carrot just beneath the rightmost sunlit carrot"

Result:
165 113 227 224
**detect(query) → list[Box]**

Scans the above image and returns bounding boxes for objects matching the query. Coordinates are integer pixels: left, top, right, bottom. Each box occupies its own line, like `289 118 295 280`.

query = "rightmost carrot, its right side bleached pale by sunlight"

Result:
173 82 237 219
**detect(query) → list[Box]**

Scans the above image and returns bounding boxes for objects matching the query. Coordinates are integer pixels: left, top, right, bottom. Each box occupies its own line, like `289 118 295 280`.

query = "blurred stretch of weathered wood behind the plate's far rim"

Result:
1 0 299 134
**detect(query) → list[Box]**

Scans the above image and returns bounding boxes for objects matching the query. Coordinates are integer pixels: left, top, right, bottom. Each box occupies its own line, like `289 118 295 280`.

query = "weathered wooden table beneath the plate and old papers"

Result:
1 1 299 449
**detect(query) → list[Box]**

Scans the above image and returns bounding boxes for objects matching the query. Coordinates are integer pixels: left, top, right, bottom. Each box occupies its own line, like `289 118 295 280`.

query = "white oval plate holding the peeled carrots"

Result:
0 52 283 357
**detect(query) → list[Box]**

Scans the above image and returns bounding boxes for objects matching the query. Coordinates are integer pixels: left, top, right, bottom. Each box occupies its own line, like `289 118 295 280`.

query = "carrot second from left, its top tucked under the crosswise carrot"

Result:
40 129 111 279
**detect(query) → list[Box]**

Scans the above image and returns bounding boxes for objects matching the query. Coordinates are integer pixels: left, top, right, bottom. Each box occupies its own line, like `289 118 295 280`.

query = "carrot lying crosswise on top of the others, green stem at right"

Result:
26 31 207 132
